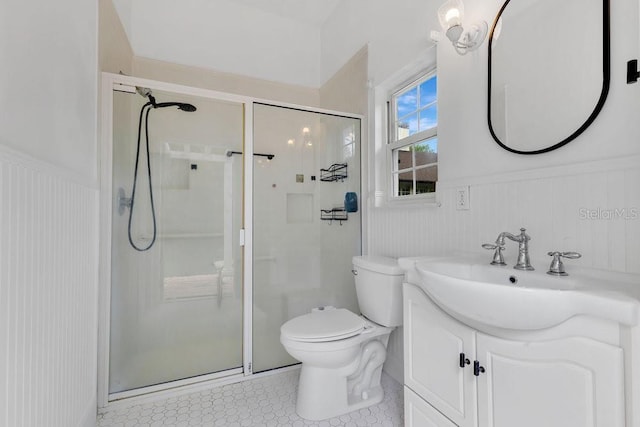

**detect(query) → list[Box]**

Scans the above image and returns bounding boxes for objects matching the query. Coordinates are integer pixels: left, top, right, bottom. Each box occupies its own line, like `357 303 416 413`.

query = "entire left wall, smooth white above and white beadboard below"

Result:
0 0 98 427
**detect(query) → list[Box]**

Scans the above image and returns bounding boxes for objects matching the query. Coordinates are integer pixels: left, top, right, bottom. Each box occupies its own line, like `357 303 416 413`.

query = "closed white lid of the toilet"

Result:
280 308 365 342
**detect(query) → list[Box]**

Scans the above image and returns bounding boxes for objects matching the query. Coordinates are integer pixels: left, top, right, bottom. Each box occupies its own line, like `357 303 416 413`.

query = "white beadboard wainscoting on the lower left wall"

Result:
0 146 98 427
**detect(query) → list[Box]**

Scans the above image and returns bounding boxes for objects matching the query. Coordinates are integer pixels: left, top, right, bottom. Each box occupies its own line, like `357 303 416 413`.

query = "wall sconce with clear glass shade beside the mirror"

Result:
438 0 489 55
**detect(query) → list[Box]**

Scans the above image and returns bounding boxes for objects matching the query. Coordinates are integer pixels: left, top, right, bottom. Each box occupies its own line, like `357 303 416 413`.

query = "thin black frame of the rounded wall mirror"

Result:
487 0 611 154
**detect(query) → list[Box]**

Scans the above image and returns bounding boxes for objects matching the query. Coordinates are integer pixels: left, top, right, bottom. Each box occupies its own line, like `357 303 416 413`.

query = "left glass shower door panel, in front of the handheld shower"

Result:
109 91 243 395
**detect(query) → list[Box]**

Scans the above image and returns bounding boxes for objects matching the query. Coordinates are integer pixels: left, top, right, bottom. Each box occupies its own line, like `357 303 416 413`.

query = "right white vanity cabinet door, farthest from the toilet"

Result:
477 334 624 427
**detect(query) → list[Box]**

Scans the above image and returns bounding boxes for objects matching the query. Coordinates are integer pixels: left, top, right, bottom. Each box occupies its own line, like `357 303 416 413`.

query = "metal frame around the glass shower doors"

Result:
97 72 368 408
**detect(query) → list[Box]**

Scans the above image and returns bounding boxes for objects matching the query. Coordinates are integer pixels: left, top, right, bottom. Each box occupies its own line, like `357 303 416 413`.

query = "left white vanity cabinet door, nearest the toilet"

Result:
404 284 477 427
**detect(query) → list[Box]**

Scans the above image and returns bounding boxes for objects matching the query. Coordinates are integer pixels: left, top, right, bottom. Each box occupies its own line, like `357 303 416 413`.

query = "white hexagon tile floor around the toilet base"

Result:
98 369 404 427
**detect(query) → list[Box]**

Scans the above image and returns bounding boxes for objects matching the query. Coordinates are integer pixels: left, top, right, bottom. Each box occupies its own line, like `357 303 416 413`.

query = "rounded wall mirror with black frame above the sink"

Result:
488 0 610 154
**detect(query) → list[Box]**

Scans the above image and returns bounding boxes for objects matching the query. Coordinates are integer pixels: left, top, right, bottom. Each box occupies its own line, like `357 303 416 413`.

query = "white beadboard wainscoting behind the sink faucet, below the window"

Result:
369 156 640 273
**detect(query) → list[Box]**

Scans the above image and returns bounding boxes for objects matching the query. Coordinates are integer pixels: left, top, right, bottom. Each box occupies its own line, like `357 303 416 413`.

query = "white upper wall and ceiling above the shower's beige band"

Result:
113 0 345 88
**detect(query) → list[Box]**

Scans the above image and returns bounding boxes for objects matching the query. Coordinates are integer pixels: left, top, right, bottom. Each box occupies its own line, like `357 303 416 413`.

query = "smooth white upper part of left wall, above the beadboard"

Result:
0 0 97 180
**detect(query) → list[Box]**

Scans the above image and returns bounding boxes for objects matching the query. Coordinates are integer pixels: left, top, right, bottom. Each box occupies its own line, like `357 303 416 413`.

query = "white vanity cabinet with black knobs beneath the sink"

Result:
404 283 625 427
